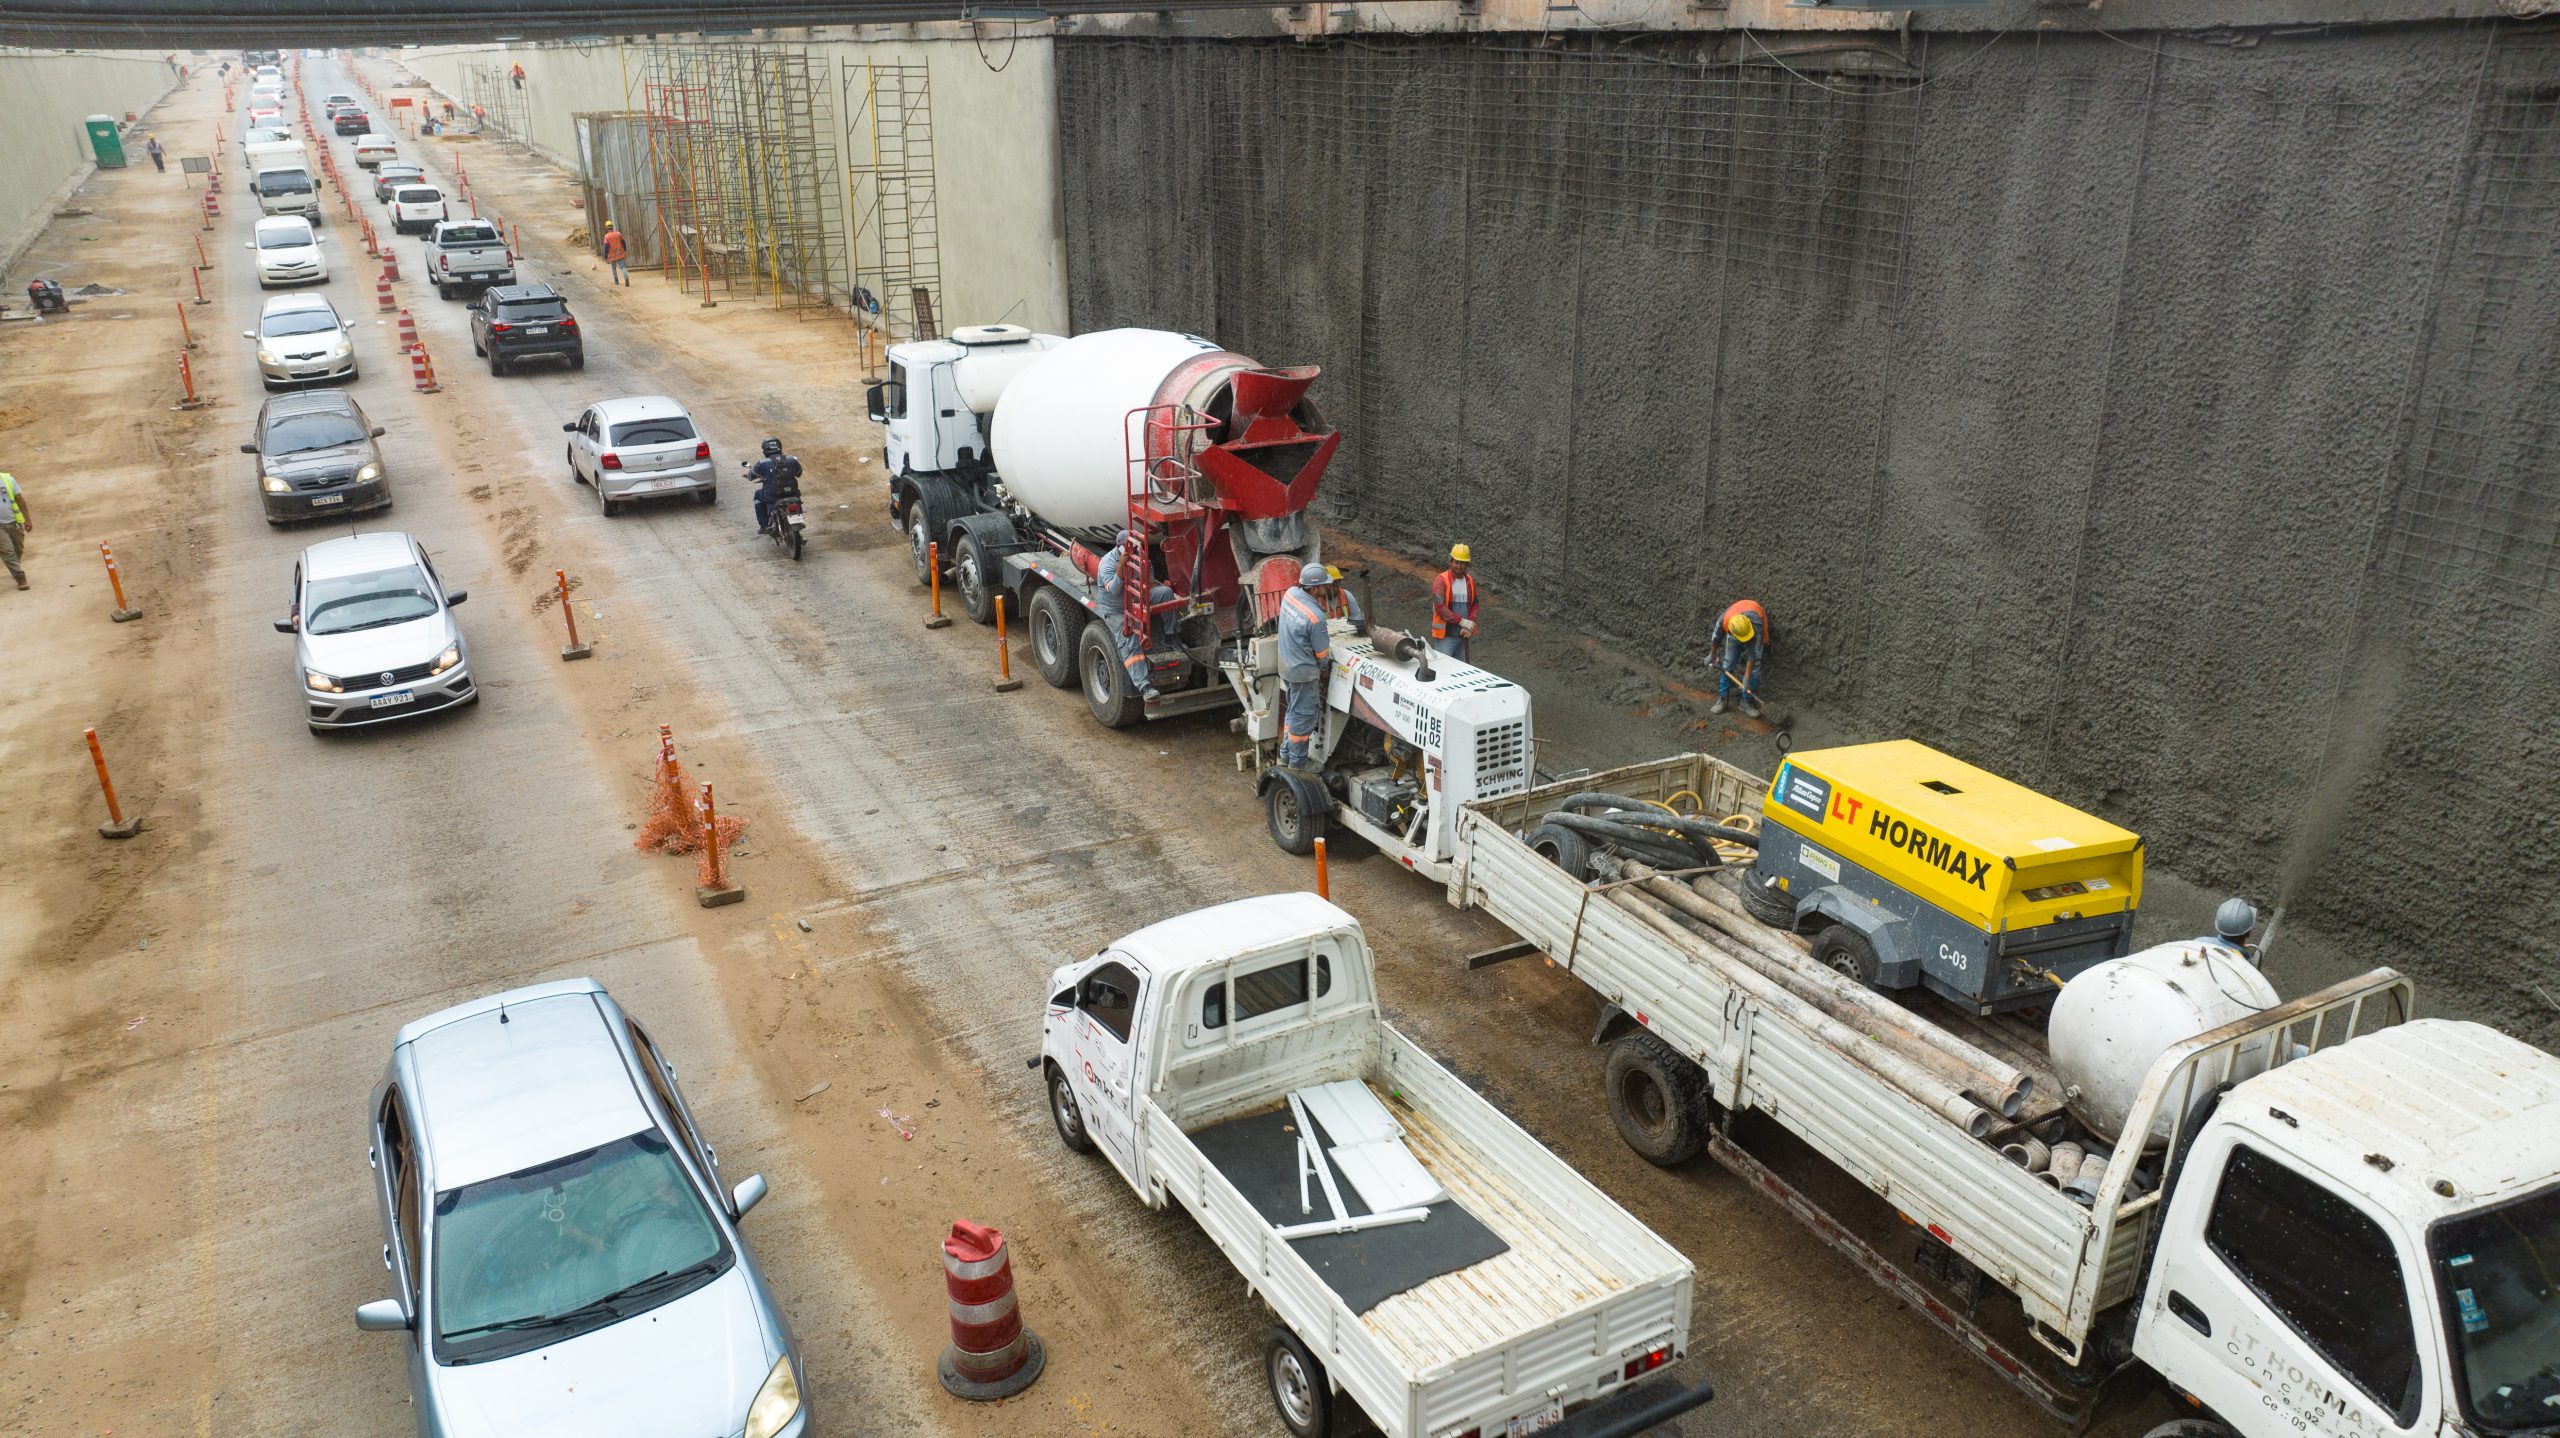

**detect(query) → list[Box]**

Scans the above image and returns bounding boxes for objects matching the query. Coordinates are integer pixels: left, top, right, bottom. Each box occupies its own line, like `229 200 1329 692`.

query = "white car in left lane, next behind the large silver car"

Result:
276 532 479 734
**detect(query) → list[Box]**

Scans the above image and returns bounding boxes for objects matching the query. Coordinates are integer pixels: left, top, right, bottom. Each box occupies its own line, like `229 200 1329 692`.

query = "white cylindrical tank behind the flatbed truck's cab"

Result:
2045 939 2278 1149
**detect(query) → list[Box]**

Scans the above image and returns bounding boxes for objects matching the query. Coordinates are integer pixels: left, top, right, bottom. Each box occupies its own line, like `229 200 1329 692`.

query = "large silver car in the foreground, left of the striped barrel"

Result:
356 977 809 1438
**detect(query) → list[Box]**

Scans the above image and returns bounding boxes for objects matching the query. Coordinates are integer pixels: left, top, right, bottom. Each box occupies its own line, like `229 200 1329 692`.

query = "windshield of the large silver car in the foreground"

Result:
435 1128 730 1361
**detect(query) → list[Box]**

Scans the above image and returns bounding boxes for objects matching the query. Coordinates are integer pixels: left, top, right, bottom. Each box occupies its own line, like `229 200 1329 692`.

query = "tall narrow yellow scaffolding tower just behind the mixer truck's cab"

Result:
842 61 942 374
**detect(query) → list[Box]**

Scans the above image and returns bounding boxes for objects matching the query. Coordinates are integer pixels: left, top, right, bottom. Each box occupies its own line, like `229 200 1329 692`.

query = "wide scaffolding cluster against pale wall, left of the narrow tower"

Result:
635 43 852 310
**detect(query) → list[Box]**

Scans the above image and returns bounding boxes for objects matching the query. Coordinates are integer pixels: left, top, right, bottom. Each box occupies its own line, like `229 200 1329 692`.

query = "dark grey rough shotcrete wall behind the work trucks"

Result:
1057 23 2560 1036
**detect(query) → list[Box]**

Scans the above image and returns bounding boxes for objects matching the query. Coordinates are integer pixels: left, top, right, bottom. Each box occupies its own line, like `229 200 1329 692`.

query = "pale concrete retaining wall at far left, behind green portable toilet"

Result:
0 51 183 273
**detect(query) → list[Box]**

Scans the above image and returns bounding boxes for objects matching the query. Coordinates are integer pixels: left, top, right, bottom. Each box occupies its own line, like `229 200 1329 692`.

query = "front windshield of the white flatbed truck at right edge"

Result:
2427 1187 2560 1433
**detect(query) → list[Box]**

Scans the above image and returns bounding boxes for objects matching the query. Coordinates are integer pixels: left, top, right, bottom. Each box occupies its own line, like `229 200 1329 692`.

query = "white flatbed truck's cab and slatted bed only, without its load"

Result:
1449 755 2560 1438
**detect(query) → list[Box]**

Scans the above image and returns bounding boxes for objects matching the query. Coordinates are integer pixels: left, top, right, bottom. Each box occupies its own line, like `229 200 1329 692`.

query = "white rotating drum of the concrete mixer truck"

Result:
991 330 1223 530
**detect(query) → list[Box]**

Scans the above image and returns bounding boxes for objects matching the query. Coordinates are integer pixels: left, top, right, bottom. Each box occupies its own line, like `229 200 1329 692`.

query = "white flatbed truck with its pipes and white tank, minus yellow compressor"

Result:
1449 736 2560 1438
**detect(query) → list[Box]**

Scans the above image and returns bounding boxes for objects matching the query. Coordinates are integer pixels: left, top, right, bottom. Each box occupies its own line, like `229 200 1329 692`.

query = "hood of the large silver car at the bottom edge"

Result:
430 1264 773 1438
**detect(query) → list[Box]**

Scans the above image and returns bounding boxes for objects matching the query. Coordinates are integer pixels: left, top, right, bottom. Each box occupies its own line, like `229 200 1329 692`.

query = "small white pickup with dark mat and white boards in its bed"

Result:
1032 893 1713 1438
